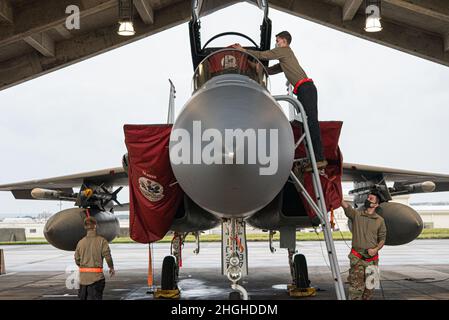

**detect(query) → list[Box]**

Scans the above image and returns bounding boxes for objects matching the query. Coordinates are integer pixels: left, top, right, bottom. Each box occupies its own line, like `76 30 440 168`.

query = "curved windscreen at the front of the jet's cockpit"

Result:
193 49 268 91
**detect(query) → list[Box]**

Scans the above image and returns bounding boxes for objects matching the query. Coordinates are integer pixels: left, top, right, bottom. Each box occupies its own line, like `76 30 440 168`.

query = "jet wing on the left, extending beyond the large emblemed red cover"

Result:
0 167 128 199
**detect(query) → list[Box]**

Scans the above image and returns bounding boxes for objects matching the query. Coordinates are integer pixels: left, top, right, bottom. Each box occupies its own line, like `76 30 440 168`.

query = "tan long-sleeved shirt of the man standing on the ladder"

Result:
246 47 307 86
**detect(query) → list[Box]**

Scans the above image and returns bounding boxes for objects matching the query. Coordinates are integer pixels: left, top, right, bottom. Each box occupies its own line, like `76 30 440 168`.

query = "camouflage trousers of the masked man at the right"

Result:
348 253 378 300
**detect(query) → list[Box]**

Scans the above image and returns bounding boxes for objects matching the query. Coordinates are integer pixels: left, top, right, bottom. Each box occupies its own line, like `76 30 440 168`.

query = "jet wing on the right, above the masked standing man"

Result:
342 163 449 192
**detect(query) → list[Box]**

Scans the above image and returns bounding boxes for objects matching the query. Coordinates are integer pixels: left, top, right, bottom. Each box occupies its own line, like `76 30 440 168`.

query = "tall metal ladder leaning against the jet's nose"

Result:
273 91 346 300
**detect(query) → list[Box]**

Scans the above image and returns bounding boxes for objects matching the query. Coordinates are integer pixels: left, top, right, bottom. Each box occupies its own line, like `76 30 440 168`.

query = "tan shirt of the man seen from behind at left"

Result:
75 230 114 286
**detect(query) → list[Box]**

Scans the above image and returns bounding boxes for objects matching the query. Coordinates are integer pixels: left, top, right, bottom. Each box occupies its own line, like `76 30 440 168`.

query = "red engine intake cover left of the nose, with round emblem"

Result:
124 125 183 243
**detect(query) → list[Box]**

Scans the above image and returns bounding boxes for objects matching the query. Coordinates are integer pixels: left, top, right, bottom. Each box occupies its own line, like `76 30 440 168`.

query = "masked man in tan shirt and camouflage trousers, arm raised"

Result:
342 194 387 300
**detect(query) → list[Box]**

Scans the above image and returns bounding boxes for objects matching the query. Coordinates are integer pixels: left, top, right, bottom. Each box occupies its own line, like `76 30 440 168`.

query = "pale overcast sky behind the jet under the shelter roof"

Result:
0 3 449 216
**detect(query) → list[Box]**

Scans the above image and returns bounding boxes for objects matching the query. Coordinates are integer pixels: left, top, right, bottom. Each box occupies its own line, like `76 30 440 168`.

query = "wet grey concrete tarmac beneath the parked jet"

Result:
0 240 449 300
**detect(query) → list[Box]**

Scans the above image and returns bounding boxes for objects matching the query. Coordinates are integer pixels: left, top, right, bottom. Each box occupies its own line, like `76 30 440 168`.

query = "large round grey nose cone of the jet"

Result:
170 75 294 217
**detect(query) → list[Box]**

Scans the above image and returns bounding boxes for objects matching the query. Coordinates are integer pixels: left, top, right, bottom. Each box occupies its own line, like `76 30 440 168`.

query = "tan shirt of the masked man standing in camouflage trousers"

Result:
344 207 387 250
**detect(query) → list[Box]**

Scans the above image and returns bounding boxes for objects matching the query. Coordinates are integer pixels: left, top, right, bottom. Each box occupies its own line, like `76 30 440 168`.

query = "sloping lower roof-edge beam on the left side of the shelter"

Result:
0 0 239 90
